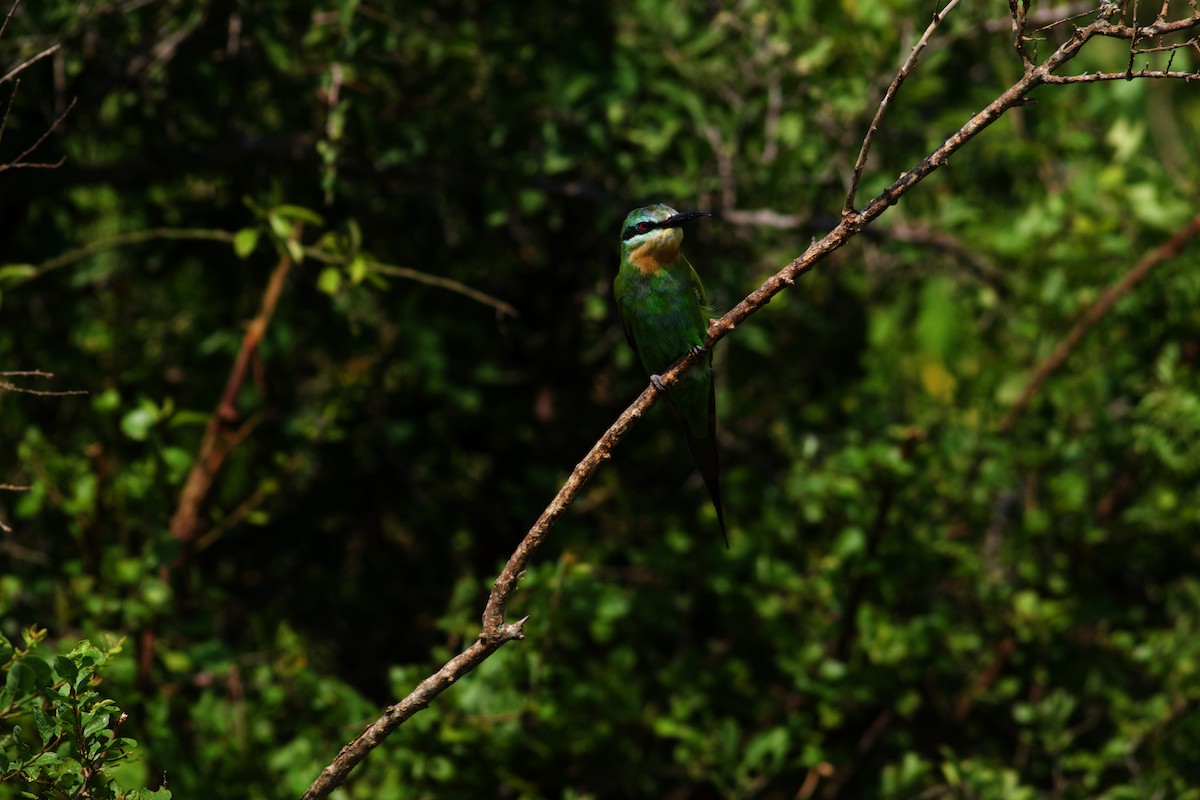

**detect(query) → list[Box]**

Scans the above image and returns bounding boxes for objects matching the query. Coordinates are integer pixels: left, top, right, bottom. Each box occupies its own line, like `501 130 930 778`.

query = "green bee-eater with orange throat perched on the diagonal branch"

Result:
612 203 730 547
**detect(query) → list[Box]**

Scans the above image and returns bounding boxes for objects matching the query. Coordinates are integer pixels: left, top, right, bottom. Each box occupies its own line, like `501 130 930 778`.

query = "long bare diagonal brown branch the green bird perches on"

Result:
302 5 1200 800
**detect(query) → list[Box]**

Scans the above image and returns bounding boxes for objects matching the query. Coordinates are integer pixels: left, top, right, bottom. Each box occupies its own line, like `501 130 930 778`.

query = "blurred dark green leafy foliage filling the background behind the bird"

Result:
0 0 1200 800
